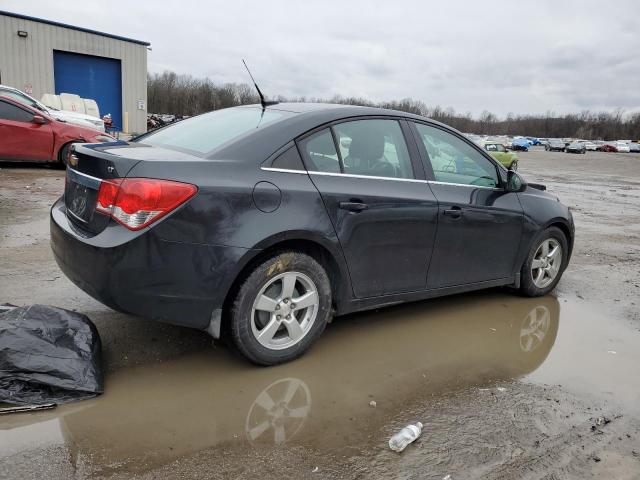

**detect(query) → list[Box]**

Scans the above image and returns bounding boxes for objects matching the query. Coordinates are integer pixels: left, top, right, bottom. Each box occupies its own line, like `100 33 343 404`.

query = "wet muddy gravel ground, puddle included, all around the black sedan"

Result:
0 150 640 479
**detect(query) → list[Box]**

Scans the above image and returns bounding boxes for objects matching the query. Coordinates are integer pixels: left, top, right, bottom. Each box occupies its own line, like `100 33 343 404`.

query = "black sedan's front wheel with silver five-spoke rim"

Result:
520 227 569 297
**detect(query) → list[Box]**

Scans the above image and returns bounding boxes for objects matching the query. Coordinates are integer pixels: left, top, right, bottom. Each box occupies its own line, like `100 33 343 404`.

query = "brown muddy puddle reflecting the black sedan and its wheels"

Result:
0 292 640 473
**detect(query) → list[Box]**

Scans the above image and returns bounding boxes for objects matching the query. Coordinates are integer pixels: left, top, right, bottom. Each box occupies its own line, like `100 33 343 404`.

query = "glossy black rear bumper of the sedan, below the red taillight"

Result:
50 200 247 329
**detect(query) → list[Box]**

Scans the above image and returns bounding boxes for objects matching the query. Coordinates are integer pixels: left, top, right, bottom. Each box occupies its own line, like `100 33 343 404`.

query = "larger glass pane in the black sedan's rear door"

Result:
333 119 414 178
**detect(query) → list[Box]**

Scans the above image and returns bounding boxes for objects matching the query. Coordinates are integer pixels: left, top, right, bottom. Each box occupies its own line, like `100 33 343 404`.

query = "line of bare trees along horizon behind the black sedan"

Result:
147 71 640 140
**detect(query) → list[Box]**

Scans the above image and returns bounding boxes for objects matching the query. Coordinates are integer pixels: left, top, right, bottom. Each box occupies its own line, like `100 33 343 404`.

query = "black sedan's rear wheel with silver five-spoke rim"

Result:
230 251 332 365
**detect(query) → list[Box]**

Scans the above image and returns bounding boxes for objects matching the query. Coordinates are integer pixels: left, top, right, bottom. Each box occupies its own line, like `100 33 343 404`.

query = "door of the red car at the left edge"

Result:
0 98 53 160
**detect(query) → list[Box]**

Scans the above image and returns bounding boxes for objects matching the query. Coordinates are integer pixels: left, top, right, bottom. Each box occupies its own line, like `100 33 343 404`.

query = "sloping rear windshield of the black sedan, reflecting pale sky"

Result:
140 107 294 155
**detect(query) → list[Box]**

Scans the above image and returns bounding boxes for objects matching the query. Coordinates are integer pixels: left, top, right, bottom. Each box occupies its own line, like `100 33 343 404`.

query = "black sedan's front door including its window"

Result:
412 123 523 288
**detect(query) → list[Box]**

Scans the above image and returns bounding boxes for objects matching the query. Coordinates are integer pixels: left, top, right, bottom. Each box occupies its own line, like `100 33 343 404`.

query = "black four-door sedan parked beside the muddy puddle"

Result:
51 103 574 365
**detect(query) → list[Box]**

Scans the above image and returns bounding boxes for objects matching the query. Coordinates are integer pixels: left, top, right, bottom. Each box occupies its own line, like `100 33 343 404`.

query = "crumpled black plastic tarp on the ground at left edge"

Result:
0 305 103 405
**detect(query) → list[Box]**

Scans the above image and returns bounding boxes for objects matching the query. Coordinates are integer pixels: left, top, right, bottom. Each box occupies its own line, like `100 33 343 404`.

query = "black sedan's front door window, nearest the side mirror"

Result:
415 123 498 187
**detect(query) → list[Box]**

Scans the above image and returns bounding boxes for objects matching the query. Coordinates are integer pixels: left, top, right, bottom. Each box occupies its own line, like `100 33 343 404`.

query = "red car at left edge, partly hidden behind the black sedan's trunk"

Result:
0 96 115 164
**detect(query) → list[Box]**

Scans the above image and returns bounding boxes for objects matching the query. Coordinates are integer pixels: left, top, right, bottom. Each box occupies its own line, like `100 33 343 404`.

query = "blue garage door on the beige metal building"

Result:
53 50 122 130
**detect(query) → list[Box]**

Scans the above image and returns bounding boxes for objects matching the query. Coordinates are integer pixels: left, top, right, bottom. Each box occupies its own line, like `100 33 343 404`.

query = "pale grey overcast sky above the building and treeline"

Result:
5 0 640 115
